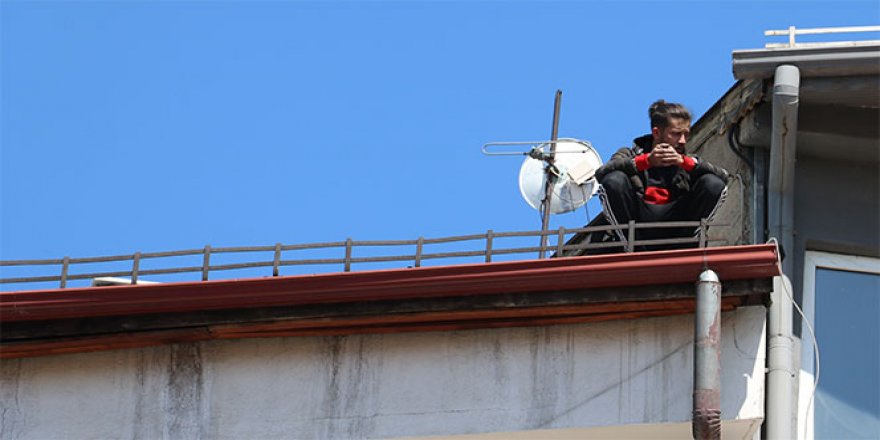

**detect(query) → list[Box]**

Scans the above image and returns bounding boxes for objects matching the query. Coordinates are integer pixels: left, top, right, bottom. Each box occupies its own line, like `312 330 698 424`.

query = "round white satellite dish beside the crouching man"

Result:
519 138 602 214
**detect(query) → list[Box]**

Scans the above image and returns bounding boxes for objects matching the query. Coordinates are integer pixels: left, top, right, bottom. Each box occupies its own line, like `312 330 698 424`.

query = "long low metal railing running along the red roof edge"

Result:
0 221 729 289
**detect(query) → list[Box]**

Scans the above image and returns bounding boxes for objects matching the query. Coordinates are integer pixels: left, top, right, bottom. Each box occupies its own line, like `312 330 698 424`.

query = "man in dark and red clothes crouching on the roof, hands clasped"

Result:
596 99 728 246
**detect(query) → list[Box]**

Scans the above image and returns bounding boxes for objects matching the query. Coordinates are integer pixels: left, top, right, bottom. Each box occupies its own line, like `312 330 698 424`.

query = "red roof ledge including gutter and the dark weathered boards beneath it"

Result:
0 245 779 358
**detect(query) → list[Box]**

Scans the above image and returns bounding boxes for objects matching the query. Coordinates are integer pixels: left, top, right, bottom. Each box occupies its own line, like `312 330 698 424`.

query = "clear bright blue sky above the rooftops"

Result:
0 0 880 288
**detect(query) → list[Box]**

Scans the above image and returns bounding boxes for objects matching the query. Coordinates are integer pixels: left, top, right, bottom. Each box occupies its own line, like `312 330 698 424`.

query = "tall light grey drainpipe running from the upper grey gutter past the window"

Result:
765 65 800 440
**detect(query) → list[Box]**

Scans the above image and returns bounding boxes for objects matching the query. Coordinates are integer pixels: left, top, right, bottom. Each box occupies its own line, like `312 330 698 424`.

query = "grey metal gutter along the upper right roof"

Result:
733 45 880 79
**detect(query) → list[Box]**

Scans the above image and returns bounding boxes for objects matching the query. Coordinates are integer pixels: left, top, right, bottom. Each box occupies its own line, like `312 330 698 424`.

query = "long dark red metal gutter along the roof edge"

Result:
0 245 779 323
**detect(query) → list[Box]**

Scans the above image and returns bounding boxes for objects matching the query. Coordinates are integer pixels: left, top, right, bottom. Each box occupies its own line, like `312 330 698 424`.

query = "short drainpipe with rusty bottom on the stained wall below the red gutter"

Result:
692 269 721 440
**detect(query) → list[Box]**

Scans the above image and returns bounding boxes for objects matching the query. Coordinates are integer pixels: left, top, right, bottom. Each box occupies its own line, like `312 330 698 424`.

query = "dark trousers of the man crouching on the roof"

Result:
599 171 726 240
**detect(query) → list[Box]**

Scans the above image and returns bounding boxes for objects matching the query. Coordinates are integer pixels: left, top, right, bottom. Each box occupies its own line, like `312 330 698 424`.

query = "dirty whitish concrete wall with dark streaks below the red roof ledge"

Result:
0 307 765 440
